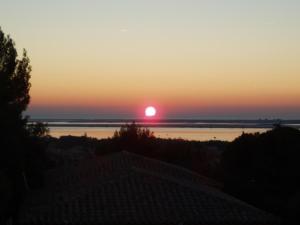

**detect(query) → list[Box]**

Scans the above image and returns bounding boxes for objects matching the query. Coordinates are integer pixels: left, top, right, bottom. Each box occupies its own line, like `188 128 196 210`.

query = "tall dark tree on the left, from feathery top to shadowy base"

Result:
0 28 44 224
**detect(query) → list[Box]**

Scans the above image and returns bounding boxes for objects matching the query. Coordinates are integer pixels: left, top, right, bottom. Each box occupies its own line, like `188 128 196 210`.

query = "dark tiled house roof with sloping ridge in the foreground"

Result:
18 152 278 225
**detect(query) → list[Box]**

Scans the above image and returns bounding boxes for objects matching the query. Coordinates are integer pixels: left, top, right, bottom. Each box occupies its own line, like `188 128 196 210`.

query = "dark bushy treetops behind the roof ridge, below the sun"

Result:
92 123 228 178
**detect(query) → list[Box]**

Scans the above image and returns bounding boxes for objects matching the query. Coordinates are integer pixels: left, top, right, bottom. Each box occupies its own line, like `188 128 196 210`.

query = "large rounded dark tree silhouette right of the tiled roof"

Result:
221 125 300 222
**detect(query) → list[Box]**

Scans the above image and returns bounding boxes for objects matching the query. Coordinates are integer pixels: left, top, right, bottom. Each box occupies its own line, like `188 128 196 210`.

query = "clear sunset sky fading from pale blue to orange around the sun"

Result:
0 0 300 119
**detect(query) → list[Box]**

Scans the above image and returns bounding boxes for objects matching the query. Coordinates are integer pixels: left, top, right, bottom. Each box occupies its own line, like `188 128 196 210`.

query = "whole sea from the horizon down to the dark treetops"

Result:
30 119 300 141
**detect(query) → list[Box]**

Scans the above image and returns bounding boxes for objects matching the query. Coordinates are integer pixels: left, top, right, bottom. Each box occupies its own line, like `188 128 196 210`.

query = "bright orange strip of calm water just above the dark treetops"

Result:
50 125 269 141
